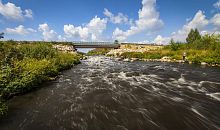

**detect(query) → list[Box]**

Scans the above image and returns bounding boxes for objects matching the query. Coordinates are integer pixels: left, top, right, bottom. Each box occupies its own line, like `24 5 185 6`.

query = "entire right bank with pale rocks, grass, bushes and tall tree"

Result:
89 29 220 66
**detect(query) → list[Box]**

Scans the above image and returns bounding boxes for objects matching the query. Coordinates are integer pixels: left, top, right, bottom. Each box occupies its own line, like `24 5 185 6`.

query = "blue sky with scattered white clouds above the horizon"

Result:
0 0 220 44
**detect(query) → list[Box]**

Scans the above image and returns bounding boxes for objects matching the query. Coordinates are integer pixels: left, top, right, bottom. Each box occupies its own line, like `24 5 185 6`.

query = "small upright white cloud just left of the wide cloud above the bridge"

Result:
38 23 58 41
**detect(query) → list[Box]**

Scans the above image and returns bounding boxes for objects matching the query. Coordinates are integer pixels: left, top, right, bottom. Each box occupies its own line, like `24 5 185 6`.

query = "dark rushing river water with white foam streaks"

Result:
0 57 220 130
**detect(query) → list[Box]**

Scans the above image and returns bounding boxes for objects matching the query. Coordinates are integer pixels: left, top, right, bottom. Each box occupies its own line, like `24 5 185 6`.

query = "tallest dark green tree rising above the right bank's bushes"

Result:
186 28 201 44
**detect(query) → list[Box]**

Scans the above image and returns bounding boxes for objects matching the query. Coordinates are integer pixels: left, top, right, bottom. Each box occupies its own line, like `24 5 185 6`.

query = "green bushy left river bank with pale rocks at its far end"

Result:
0 40 81 116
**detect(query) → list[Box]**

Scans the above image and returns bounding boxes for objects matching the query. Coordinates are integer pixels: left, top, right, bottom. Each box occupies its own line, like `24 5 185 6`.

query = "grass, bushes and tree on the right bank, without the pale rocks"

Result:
111 32 220 65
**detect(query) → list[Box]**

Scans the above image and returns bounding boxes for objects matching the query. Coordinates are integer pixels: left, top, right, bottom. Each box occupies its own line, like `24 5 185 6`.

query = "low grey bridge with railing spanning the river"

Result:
71 42 120 49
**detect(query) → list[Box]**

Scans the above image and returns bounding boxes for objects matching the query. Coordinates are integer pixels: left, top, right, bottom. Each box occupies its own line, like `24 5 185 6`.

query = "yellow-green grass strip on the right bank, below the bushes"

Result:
120 49 220 64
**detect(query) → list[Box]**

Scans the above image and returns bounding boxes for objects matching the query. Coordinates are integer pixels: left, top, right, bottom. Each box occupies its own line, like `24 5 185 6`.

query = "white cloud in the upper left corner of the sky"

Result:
0 0 33 20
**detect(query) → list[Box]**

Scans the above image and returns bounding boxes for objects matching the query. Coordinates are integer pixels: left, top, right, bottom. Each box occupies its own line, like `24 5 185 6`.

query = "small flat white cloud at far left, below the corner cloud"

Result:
5 25 36 35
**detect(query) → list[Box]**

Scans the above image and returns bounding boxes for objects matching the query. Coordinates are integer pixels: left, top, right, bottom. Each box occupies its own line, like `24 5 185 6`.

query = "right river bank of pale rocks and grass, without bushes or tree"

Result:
105 44 220 66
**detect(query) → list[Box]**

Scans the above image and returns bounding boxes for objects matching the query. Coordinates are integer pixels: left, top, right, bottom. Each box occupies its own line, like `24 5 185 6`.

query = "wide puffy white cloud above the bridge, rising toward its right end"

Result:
64 16 107 41
